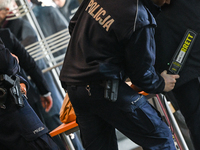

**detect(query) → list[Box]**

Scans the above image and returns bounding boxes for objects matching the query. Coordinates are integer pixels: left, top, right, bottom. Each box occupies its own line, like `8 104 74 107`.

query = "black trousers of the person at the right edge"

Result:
173 78 200 150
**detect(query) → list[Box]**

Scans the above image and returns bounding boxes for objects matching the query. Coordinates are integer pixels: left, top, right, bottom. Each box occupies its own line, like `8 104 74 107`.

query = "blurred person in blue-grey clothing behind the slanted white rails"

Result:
27 0 69 61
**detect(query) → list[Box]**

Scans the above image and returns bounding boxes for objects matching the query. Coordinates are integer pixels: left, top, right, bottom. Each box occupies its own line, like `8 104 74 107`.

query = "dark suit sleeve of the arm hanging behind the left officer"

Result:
0 29 49 103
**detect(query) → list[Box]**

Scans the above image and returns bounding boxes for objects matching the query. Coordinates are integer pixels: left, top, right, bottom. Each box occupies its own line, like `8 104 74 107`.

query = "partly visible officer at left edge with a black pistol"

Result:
0 39 59 150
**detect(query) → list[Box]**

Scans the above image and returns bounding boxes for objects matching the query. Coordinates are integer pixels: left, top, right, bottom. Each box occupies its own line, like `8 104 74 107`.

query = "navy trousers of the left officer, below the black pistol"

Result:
0 96 59 150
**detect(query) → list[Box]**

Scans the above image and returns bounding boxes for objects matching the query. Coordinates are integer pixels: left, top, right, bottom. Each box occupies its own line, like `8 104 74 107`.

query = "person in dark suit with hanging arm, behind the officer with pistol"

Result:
0 29 70 150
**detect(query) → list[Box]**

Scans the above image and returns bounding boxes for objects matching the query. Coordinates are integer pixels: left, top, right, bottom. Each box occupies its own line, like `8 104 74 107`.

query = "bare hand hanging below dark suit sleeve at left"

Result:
40 95 53 112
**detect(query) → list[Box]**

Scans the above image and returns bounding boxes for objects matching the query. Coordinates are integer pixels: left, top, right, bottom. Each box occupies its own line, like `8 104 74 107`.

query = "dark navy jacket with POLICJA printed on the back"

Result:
60 0 165 93
